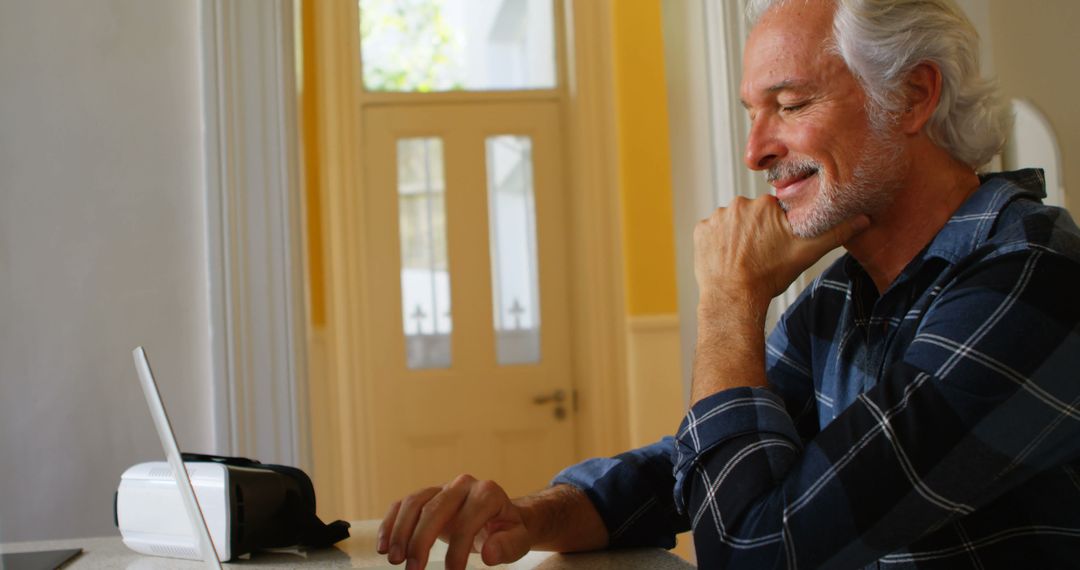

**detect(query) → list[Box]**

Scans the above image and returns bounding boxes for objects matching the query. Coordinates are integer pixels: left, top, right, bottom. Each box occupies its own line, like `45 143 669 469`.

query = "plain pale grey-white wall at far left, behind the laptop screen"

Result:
0 0 215 542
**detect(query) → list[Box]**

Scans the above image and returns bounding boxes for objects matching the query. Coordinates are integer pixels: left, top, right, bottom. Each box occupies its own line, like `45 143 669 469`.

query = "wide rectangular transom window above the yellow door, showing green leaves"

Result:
360 0 555 92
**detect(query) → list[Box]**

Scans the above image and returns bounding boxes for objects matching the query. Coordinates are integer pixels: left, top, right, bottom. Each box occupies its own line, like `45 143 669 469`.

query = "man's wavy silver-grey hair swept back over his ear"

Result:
746 0 1012 168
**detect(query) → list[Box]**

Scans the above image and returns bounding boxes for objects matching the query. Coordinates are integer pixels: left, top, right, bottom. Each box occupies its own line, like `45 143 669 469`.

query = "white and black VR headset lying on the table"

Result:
113 453 349 560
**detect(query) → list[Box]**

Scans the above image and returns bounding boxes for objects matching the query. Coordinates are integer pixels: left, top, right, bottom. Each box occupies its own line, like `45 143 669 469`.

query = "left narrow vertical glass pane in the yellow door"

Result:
397 137 453 368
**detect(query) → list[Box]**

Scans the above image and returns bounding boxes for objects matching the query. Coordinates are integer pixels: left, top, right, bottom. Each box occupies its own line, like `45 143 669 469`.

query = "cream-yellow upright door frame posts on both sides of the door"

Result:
301 0 629 518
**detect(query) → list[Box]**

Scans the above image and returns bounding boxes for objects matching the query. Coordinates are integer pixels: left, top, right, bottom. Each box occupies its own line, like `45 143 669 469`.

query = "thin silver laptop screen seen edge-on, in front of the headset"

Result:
132 347 221 570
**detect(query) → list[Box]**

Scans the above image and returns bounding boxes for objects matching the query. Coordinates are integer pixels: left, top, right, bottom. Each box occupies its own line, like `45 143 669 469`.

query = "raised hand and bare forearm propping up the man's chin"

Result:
690 195 869 405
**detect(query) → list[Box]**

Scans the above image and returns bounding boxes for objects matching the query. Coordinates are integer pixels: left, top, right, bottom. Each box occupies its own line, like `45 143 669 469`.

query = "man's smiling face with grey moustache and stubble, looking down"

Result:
741 0 905 236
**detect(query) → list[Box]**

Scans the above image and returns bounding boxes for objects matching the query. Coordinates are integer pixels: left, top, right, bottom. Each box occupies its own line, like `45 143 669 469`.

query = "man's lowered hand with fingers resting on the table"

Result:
376 475 532 570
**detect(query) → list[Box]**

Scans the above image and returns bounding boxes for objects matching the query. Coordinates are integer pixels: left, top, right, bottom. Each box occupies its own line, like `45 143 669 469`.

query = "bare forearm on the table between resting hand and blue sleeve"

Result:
513 485 608 552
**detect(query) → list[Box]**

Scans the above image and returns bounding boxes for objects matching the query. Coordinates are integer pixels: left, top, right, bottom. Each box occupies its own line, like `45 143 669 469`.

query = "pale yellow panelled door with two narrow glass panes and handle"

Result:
361 101 575 505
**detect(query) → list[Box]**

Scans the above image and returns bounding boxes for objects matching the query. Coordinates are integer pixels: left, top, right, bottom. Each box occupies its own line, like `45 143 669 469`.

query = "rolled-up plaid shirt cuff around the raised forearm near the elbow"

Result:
672 388 802 513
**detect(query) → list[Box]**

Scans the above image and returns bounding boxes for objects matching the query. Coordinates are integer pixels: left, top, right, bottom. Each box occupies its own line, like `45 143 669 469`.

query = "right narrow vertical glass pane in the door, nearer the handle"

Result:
486 136 540 365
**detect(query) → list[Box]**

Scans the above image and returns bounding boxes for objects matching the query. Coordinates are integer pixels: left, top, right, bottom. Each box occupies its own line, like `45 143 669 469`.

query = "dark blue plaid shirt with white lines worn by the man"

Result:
555 171 1080 569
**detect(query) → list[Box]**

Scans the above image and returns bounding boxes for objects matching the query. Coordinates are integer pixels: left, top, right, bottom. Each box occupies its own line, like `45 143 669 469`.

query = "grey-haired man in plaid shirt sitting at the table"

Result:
378 0 1080 569
